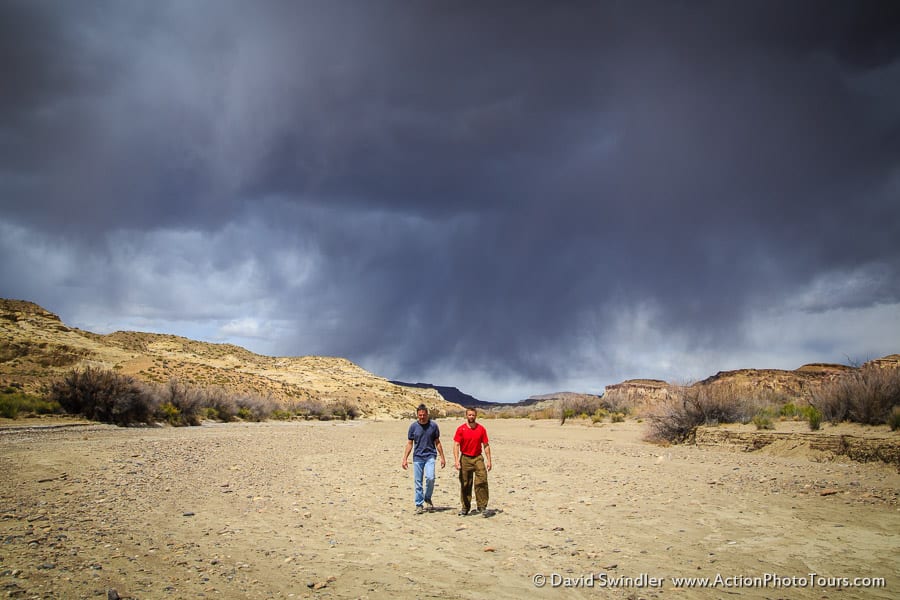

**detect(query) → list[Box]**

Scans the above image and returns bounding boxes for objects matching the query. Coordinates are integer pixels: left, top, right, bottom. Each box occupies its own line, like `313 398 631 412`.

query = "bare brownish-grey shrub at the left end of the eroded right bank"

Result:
647 385 756 443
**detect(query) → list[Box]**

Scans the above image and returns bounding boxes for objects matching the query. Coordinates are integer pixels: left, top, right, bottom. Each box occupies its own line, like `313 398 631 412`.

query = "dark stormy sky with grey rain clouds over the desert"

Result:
0 0 900 401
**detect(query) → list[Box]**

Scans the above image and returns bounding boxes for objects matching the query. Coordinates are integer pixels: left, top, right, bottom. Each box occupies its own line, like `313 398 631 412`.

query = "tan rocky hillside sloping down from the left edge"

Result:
0 299 463 417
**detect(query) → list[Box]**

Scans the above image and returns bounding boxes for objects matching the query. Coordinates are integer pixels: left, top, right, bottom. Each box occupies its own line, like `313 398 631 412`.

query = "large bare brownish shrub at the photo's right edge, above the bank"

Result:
810 367 900 425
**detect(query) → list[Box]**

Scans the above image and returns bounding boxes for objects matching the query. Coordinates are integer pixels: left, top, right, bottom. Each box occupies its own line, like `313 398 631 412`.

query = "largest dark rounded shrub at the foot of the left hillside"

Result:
48 367 155 425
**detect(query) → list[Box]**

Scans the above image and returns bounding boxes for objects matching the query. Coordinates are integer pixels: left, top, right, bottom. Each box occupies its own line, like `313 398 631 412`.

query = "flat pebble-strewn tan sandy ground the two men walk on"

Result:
0 420 900 599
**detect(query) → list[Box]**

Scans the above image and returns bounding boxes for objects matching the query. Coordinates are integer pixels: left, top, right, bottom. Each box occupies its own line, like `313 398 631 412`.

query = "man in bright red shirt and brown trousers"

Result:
453 408 491 517
